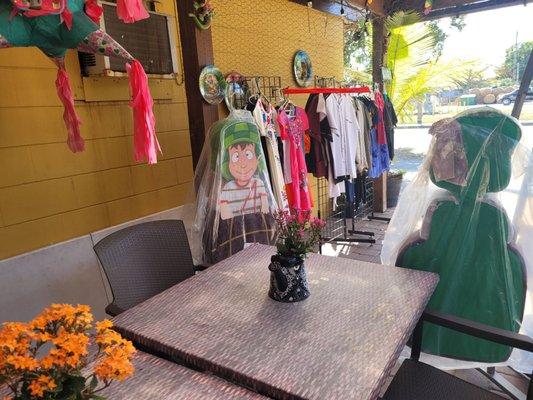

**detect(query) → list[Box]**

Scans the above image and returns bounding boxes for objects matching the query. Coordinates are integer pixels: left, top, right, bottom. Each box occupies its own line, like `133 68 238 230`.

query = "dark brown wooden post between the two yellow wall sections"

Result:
176 0 218 167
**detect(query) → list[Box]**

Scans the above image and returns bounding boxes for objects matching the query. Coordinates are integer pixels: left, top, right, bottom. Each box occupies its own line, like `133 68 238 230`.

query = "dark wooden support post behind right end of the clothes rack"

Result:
372 17 387 212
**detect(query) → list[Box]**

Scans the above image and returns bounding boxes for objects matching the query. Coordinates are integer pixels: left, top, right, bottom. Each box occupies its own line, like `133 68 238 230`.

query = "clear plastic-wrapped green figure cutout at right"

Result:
381 107 533 372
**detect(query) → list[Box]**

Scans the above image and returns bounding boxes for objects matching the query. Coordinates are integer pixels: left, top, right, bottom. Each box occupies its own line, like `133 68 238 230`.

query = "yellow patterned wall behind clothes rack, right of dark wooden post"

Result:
212 0 344 211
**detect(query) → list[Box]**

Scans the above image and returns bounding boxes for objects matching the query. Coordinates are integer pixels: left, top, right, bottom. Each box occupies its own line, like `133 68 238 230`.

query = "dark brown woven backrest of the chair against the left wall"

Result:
94 220 194 310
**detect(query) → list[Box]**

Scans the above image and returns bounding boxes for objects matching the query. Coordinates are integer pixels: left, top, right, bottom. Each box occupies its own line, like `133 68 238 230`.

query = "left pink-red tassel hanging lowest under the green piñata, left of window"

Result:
56 68 85 153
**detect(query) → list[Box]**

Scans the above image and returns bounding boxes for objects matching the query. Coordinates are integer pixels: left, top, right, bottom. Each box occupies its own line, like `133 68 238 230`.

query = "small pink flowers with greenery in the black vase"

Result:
274 210 326 258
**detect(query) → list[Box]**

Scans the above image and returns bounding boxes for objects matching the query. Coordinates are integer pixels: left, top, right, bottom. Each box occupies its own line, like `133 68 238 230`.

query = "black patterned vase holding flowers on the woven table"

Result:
268 254 311 303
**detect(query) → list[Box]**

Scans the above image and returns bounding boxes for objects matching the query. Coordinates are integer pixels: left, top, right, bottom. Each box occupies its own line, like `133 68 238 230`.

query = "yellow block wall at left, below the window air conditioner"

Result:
0 0 193 259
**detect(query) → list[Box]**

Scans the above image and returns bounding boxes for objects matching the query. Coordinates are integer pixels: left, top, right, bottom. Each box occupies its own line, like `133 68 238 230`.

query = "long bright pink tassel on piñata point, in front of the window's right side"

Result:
126 60 161 164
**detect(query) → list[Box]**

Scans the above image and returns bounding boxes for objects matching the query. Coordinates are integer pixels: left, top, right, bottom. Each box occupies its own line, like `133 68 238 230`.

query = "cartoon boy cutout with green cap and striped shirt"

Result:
204 120 275 263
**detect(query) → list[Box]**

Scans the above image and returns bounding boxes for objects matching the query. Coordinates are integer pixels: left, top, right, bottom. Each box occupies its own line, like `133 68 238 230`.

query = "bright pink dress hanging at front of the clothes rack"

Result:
278 107 312 210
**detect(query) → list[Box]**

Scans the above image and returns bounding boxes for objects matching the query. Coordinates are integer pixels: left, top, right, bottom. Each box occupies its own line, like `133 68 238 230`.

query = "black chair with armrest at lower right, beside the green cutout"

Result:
383 311 533 400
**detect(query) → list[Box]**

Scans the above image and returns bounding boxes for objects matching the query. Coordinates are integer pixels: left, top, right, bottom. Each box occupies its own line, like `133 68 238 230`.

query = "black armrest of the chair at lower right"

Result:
422 310 533 353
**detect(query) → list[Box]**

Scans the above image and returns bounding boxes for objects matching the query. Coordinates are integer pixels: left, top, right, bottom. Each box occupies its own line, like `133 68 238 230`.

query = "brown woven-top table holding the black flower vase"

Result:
111 244 438 400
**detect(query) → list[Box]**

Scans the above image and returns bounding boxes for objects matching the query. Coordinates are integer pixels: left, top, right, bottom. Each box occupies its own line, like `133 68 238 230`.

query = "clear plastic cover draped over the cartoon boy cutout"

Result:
193 110 277 264
